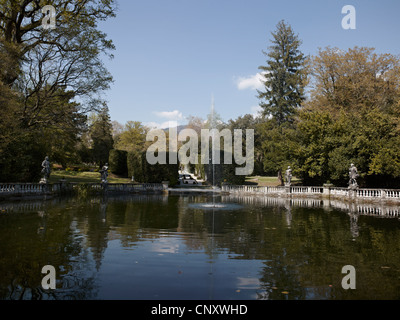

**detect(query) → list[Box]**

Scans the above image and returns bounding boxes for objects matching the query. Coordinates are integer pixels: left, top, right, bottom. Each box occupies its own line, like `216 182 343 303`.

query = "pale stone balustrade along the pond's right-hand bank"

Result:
221 185 400 201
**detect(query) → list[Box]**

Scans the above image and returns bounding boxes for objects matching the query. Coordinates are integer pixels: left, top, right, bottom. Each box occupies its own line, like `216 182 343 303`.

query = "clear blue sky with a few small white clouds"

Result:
100 0 400 127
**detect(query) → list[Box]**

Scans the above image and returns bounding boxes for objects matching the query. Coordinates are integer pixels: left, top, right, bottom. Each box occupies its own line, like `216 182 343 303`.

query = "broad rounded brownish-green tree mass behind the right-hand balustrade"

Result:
257 42 400 188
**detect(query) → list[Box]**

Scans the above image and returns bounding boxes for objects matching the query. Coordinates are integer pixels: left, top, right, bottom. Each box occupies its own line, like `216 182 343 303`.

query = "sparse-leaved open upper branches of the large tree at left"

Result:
0 0 115 101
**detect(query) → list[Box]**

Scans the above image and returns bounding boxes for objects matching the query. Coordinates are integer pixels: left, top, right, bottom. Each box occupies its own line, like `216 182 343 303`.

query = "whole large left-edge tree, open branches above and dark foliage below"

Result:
0 0 115 182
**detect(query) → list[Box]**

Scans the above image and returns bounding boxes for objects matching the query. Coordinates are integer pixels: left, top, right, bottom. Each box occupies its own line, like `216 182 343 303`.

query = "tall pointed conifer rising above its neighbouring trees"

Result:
255 21 307 184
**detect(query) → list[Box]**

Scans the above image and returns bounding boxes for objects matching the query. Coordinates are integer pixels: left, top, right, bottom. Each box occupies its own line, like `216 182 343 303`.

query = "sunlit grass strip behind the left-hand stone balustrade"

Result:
50 170 131 183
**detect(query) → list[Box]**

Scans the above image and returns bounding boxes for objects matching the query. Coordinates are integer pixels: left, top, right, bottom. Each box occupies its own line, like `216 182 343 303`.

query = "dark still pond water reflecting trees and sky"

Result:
0 195 400 300
